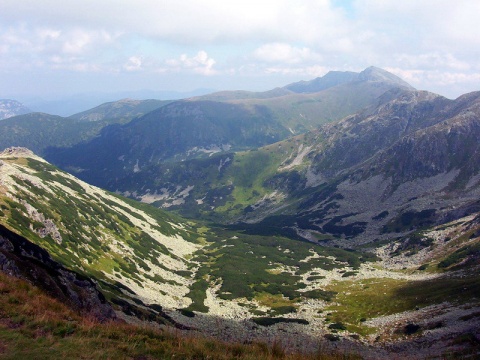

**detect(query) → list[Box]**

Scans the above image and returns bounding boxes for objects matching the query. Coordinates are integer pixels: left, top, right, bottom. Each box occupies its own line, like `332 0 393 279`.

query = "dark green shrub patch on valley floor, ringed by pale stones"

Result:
184 227 369 306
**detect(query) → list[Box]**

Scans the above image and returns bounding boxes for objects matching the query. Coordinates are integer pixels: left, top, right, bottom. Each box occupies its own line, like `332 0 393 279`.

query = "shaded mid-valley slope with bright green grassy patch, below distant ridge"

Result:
119 136 314 223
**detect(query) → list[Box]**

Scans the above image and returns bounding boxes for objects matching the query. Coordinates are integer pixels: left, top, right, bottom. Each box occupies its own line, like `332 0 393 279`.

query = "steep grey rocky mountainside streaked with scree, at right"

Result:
238 93 480 245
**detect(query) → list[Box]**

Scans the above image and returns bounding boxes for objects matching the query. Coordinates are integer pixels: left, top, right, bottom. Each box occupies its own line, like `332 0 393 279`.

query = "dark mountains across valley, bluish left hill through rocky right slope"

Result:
40 76 480 250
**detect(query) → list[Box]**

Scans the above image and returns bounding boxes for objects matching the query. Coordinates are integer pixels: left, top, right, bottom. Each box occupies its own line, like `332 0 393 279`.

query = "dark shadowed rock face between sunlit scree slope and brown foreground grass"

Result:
0 225 116 320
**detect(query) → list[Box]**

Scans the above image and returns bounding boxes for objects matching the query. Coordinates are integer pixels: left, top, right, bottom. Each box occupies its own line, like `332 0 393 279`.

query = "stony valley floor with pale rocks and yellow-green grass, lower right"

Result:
158 218 480 359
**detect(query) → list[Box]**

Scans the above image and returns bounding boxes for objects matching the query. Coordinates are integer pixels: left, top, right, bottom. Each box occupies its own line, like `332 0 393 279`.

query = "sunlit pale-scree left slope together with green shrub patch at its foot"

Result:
0 148 372 316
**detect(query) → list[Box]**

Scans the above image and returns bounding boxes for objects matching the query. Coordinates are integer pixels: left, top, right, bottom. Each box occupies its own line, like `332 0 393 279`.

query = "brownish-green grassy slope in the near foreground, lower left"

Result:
0 273 357 360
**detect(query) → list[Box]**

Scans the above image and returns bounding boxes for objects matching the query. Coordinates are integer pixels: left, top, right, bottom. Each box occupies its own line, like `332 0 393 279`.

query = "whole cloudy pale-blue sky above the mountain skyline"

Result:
0 0 480 98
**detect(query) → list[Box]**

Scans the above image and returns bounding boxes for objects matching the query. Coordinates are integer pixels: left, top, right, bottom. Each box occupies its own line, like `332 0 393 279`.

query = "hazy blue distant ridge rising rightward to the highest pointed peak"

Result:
43 68 414 189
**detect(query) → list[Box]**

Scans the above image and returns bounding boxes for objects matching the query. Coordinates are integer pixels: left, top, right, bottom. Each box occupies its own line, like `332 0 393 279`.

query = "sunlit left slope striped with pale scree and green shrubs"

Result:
1 149 199 307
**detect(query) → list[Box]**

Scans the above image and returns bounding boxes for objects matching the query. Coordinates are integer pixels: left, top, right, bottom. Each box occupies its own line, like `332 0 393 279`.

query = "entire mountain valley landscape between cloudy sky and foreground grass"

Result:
0 67 480 359
